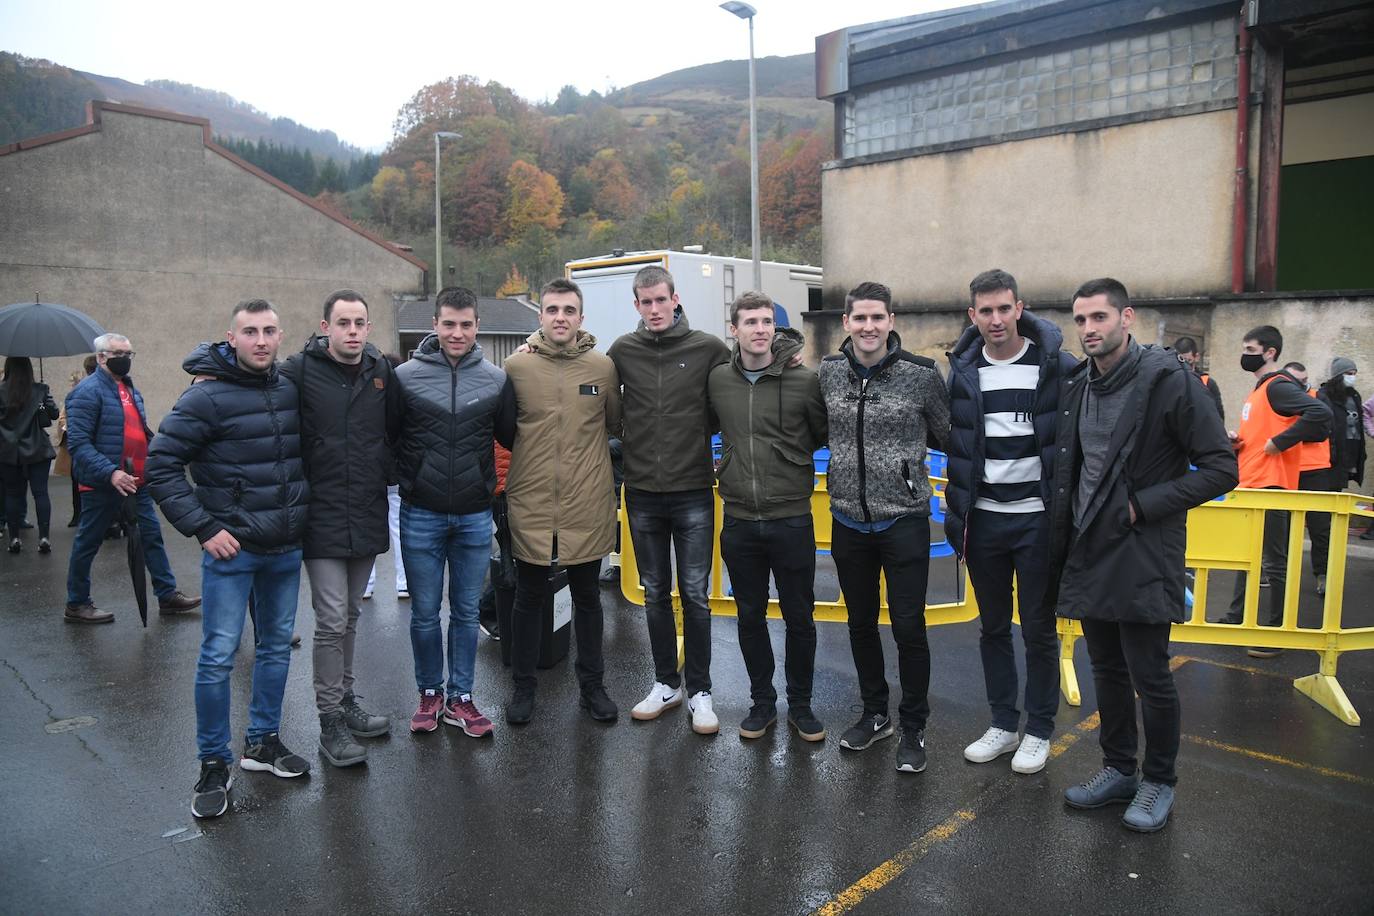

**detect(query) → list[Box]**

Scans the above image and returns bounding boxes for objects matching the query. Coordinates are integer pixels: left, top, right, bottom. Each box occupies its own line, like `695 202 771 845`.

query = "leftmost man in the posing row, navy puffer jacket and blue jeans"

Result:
146 299 311 817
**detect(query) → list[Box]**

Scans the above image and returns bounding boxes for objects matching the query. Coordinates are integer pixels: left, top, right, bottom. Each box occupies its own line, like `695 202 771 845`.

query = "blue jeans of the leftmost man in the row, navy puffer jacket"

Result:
192 549 301 762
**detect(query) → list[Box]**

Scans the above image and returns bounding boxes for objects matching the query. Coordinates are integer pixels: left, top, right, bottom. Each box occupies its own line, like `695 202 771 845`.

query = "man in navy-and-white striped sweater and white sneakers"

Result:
945 269 1074 773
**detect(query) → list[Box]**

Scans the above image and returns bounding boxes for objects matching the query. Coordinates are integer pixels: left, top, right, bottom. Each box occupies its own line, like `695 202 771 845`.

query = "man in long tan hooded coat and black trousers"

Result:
503 279 620 725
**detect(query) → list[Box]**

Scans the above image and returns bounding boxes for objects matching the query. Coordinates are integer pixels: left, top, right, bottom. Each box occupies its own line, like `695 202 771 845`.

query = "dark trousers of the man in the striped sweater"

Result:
966 509 1059 737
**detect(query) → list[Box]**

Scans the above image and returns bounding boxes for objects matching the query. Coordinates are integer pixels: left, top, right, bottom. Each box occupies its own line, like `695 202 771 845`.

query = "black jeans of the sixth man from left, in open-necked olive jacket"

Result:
720 515 816 710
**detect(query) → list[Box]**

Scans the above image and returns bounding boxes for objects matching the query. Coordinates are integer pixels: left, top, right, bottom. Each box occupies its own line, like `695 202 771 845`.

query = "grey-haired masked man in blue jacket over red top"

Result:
65 334 201 623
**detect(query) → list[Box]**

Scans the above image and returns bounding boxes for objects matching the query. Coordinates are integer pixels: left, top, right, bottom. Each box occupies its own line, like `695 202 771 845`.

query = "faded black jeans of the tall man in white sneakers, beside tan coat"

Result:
625 486 716 695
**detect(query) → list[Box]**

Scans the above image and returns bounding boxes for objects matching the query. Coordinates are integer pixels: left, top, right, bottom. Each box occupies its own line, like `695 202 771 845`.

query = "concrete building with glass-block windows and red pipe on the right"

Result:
805 0 1374 458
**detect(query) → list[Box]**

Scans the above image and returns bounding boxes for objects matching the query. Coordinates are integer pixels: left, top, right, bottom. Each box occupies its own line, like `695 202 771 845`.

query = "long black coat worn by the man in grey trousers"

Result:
282 335 400 560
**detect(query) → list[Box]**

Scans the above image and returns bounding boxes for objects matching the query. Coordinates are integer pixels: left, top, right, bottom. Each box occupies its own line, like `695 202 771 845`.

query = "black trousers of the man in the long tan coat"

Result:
513 559 606 691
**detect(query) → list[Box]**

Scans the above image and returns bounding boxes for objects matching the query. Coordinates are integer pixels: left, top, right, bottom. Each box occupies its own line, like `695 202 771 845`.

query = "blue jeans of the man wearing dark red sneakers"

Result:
401 503 492 699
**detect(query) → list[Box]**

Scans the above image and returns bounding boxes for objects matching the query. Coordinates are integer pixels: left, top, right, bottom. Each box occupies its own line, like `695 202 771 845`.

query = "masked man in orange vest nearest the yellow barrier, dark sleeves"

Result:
1221 324 1331 658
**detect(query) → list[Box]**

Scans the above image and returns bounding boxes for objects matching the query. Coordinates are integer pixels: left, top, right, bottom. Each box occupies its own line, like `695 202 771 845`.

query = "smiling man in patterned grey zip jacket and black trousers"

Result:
819 283 949 773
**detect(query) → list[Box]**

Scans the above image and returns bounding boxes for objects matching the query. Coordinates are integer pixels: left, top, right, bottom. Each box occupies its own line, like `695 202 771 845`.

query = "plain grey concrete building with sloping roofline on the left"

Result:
0 102 426 427
